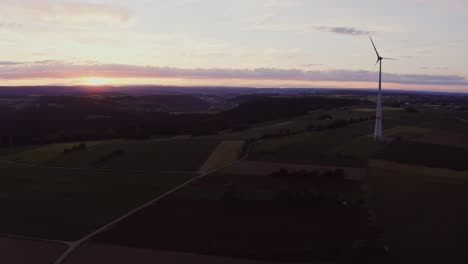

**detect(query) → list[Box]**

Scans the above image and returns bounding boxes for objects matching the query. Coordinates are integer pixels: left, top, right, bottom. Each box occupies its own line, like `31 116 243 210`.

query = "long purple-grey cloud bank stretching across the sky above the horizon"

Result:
0 61 468 85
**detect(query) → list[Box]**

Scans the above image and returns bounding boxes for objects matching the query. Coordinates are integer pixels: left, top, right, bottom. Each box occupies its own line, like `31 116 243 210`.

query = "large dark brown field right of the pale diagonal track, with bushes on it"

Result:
92 166 385 263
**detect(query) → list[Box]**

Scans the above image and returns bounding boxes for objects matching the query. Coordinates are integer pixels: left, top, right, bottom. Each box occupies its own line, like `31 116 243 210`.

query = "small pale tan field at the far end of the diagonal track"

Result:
200 140 245 172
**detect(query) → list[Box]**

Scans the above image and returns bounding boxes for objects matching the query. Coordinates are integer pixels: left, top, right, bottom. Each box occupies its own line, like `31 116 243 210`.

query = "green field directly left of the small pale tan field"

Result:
44 139 220 172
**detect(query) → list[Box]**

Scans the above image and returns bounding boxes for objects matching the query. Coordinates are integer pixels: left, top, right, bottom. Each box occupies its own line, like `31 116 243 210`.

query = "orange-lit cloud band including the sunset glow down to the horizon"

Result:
0 60 468 90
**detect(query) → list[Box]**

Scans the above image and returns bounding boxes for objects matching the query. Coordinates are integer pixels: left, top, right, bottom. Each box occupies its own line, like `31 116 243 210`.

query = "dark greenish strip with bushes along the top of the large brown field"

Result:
181 171 365 202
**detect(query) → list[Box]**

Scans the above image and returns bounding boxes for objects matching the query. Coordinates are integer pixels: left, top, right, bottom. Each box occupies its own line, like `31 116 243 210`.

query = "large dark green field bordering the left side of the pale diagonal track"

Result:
0 162 196 240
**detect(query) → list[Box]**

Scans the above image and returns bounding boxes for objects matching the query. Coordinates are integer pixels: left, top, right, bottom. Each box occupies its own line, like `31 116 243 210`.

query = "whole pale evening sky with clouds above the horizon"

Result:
0 0 468 92
